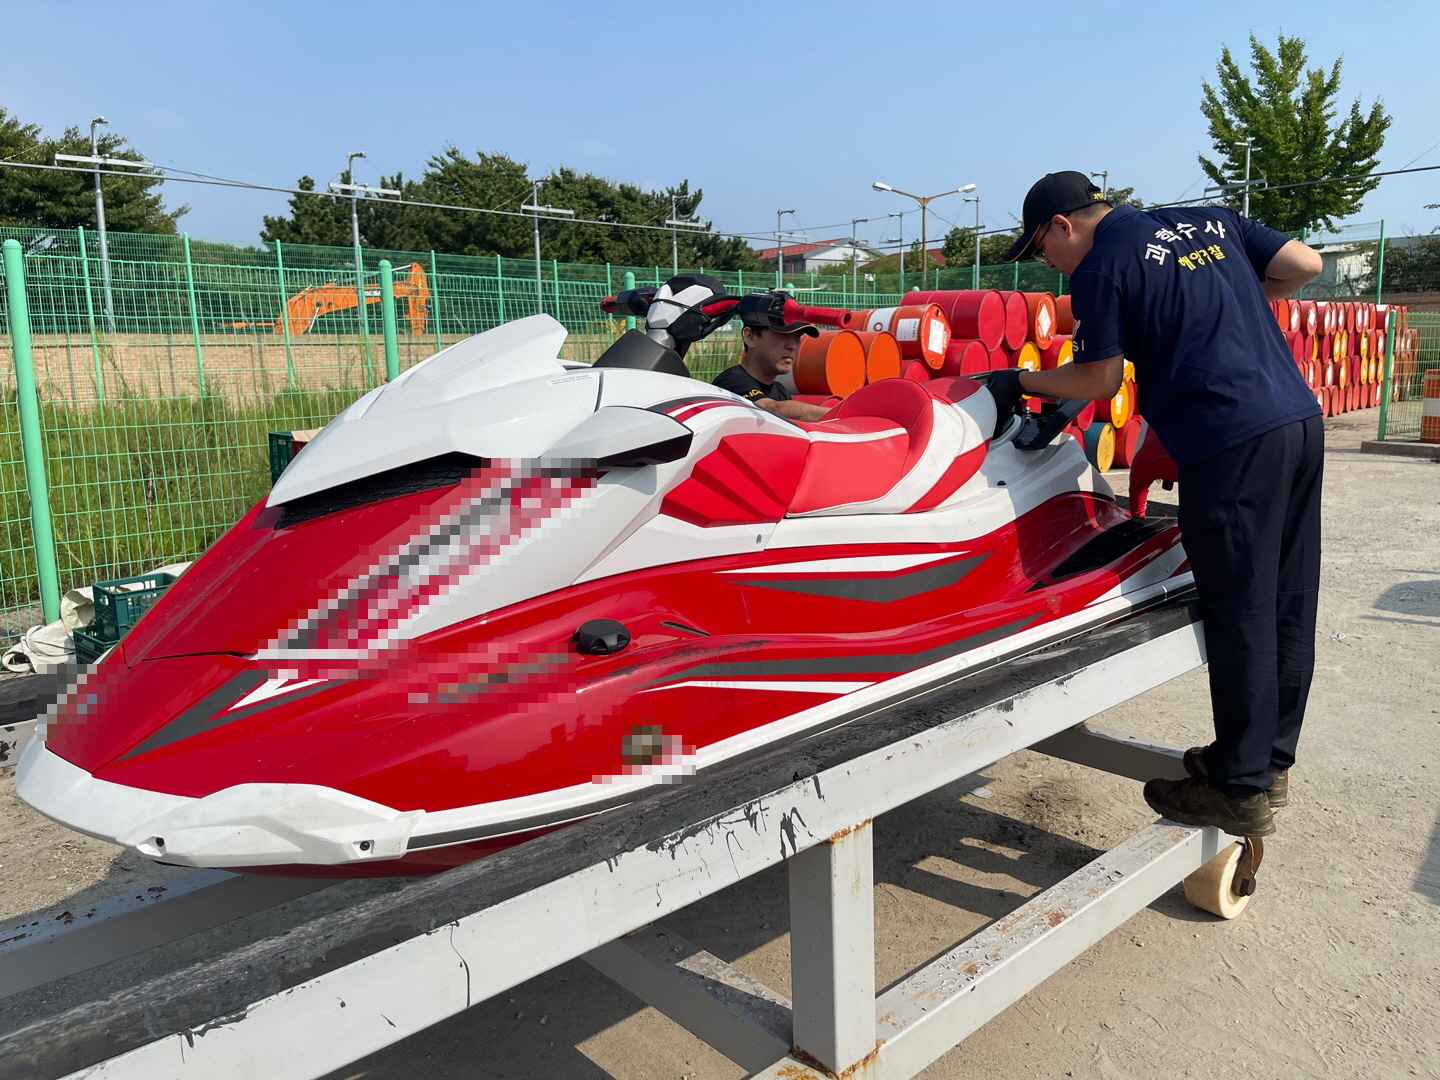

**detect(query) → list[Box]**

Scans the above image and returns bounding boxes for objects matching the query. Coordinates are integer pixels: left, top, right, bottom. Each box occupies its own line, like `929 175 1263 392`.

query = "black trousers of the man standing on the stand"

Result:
1179 416 1325 796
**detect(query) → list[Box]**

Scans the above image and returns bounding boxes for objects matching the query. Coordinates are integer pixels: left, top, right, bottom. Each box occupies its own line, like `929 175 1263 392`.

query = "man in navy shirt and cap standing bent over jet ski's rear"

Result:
992 171 1323 837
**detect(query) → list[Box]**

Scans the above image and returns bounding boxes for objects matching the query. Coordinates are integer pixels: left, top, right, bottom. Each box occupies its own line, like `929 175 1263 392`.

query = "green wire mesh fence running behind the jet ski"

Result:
0 226 1433 634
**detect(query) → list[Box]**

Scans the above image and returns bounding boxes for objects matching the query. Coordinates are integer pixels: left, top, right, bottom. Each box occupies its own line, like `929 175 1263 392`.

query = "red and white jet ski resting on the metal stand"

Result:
17 275 1189 877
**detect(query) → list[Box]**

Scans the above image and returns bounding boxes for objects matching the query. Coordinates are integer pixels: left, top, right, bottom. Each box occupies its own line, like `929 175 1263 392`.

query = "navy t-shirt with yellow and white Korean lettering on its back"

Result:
1070 206 1320 468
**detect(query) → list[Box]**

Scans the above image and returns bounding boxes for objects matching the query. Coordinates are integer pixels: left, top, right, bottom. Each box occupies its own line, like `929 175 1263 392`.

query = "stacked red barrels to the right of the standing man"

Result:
1270 300 1417 416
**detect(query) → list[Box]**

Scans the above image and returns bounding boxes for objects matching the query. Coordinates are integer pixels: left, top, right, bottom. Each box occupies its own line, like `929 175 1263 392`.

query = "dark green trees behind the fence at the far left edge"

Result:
0 108 190 233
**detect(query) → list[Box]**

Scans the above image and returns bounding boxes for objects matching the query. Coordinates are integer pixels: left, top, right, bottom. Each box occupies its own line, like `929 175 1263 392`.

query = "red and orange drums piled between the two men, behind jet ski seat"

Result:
793 289 1140 471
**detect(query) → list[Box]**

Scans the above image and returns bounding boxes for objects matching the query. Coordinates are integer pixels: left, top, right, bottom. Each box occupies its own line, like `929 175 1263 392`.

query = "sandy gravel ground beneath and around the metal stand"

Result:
0 412 1440 1080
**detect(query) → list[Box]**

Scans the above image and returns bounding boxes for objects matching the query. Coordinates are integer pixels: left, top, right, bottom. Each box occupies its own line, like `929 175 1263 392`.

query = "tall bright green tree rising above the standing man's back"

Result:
1200 35 1390 232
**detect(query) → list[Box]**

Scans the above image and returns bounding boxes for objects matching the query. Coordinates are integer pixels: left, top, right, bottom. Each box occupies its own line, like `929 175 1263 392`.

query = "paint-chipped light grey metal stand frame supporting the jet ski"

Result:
0 606 1231 1080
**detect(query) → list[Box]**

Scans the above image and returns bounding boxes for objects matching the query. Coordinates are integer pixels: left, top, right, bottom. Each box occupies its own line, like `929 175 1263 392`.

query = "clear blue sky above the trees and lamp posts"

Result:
0 0 1440 243
